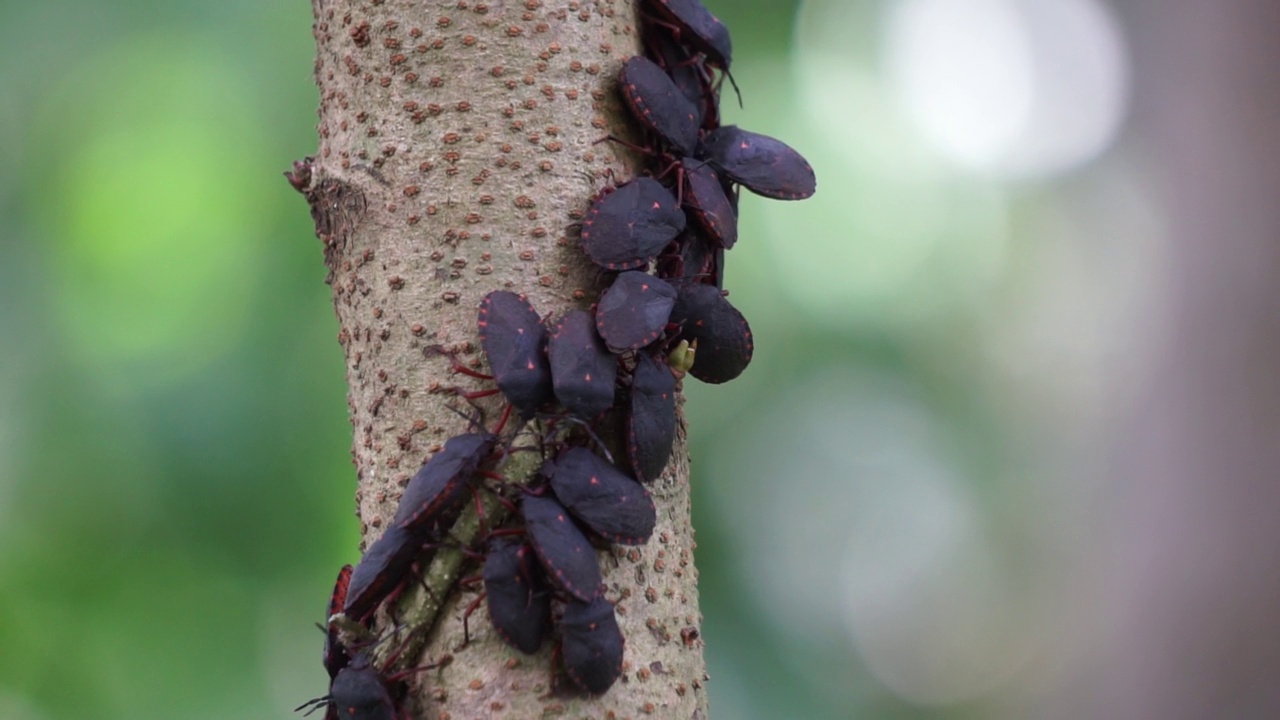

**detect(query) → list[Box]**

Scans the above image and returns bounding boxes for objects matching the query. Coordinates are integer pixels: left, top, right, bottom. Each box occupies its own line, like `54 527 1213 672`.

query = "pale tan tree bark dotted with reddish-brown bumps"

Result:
302 0 707 719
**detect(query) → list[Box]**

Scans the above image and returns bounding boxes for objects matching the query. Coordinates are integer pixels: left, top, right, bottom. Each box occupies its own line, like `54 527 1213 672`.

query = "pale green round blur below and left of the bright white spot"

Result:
783 0 1009 325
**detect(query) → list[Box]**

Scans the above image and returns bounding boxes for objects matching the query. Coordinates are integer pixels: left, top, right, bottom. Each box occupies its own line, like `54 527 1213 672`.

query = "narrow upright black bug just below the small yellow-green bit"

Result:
627 354 680 482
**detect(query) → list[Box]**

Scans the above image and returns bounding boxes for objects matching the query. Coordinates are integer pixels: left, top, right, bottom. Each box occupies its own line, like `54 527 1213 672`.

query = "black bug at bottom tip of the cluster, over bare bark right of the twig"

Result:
561 596 623 694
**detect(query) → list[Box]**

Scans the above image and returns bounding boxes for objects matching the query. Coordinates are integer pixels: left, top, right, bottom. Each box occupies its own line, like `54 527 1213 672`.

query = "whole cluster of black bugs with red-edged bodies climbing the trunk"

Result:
303 0 815 720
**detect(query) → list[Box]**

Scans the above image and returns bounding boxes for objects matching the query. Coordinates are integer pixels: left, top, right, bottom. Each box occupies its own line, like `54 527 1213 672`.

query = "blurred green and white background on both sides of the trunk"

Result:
0 0 1280 720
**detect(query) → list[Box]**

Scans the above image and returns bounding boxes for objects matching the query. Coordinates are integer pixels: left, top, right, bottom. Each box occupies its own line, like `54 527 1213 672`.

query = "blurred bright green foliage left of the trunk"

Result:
0 1 358 719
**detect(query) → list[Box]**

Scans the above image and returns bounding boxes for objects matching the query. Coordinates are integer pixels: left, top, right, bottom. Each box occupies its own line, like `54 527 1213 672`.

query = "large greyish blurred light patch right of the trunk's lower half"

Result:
709 368 1029 705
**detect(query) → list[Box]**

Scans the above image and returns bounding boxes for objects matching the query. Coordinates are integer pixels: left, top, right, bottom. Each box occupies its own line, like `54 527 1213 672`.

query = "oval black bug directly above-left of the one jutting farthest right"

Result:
618 55 699 155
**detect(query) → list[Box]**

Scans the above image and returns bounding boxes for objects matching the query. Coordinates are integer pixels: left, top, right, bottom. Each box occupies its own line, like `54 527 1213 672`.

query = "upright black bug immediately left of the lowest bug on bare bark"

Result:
484 538 552 655
